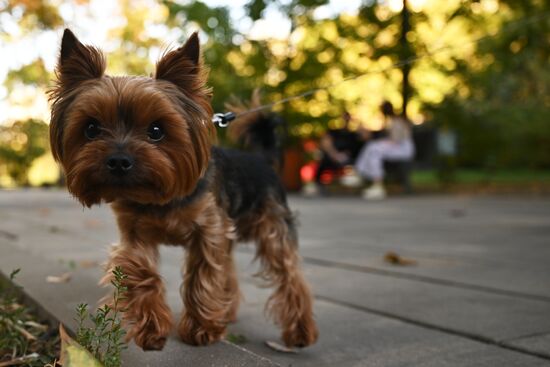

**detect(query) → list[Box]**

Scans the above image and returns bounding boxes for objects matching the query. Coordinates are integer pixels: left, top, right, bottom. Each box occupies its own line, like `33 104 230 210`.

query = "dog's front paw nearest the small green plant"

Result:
127 313 172 350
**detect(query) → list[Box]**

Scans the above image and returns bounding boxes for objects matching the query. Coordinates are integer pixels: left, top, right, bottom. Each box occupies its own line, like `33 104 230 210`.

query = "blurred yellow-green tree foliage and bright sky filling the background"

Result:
0 0 550 185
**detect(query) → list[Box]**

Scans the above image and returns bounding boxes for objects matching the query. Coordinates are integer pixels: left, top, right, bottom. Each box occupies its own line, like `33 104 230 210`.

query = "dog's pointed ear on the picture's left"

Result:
56 28 105 90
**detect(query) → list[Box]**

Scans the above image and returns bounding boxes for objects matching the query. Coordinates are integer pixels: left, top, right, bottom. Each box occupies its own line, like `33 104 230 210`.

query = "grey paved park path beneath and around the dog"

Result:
0 190 550 367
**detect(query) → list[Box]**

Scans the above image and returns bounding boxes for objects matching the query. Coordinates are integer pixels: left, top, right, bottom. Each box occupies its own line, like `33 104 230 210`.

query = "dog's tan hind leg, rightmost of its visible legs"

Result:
249 199 318 347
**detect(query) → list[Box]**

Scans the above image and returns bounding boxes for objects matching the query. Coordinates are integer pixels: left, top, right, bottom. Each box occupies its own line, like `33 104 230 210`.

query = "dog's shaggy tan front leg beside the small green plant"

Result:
101 244 172 350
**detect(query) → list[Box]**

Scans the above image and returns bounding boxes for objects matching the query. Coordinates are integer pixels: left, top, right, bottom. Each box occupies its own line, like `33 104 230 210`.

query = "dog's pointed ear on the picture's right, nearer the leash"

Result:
155 32 205 95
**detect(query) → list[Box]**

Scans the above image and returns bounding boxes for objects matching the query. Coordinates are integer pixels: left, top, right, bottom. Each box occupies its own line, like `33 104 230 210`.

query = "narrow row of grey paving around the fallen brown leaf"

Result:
302 245 550 302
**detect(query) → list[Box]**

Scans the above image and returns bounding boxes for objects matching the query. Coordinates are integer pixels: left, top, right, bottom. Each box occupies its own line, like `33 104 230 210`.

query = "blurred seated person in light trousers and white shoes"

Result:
355 101 415 200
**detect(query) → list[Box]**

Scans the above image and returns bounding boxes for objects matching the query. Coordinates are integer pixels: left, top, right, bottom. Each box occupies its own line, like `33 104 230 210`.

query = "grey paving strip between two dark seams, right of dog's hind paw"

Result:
306 258 550 340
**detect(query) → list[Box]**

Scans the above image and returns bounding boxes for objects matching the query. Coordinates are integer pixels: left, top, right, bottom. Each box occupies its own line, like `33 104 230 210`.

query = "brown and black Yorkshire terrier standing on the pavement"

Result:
50 29 318 350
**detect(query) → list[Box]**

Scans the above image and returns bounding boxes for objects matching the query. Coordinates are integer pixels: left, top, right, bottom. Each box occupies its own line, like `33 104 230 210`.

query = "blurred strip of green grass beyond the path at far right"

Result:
412 169 550 186
